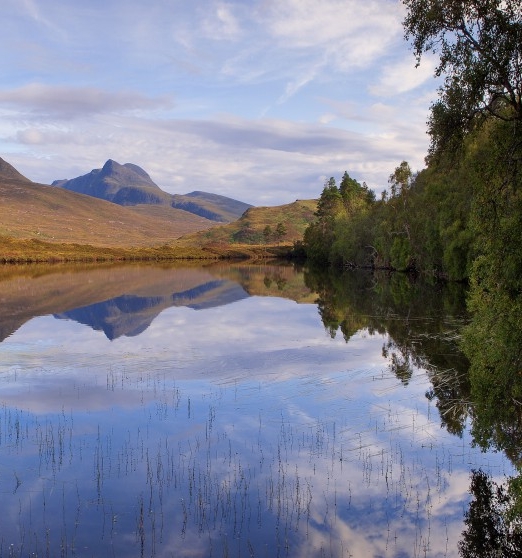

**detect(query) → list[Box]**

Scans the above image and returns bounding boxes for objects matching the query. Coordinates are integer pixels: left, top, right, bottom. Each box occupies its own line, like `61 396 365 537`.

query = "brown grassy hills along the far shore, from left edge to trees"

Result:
0 158 317 262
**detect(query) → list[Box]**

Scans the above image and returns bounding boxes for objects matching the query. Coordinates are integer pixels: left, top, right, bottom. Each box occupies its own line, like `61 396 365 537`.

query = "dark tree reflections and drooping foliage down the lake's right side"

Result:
306 266 522 557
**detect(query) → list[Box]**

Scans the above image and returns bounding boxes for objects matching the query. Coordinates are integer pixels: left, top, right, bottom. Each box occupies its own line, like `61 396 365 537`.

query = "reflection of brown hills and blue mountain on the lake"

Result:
0 264 308 341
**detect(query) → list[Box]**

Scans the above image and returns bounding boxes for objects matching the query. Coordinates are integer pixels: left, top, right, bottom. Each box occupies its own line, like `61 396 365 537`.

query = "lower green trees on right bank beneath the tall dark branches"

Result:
303 115 522 280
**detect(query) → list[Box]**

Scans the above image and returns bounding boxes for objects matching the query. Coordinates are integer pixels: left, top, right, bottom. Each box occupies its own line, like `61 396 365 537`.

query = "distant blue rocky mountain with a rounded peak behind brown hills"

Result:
52 159 252 223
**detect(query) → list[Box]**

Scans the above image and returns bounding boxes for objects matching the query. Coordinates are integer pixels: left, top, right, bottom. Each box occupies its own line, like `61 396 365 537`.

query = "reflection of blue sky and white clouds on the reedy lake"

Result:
0 264 509 557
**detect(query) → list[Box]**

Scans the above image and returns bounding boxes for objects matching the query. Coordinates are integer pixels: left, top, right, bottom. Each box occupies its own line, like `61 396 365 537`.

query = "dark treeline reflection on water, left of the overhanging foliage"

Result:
305 270 470 435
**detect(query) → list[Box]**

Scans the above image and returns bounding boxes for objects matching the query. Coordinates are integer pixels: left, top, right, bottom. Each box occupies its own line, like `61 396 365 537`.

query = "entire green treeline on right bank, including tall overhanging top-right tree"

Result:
303 0 522 288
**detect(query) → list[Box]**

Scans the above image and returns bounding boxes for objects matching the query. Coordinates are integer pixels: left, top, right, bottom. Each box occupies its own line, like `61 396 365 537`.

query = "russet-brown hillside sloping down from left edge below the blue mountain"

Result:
0 159 215 247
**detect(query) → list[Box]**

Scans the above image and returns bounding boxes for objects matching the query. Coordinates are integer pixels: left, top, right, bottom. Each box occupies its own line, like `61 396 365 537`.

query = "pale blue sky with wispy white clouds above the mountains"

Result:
0 0 438 206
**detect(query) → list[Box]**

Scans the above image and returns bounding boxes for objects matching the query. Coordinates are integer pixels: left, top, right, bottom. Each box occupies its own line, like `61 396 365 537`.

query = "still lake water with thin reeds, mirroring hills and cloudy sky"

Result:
0 265 513 558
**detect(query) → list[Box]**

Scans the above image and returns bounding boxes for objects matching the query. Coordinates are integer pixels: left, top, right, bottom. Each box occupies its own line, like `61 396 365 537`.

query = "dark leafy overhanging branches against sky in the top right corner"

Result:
403 0 522 160
